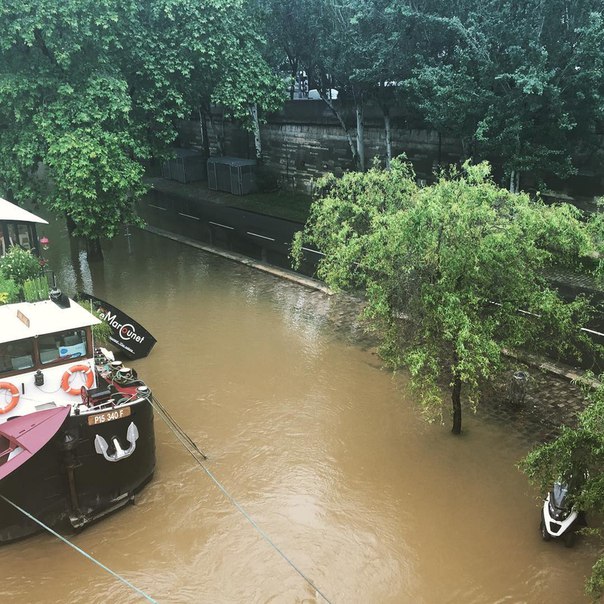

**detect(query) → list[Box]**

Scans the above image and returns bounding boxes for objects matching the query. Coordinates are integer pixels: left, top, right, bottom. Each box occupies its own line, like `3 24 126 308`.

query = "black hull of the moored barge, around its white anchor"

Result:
0 400 155 544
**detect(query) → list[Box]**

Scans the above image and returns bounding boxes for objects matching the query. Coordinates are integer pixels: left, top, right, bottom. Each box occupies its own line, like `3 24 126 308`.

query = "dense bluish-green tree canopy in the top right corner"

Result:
408 0 604 190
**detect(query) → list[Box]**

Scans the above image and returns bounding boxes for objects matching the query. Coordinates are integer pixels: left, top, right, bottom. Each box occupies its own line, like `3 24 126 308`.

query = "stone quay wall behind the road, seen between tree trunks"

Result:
179 100 461 194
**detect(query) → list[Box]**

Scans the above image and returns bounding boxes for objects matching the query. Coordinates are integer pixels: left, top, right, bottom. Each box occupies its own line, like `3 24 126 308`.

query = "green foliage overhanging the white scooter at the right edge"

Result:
521 384 604 599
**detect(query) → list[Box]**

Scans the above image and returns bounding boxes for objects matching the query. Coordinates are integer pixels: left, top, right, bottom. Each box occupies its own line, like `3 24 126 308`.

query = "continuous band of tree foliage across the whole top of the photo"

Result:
0 0 604 243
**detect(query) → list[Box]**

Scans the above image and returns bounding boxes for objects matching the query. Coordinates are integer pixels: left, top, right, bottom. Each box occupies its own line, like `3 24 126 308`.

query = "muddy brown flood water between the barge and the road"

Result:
0 232 597 604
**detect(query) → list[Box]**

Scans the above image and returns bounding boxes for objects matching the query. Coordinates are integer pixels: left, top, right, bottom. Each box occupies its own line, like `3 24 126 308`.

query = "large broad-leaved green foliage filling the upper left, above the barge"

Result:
0 0 278 248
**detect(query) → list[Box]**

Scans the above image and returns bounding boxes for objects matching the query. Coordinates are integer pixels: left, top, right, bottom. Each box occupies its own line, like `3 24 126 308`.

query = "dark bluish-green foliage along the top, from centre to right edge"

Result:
262 0 604 190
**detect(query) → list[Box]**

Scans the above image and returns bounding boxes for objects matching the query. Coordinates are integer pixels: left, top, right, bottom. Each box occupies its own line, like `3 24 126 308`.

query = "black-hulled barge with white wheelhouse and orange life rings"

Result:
0 291 155 543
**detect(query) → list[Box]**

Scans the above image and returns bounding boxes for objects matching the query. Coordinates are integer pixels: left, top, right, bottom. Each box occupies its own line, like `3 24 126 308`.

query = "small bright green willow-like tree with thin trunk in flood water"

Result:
293 159 593 434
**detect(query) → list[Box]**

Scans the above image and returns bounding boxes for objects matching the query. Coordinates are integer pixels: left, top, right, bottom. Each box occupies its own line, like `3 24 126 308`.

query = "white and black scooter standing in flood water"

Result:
540 482 586 547
